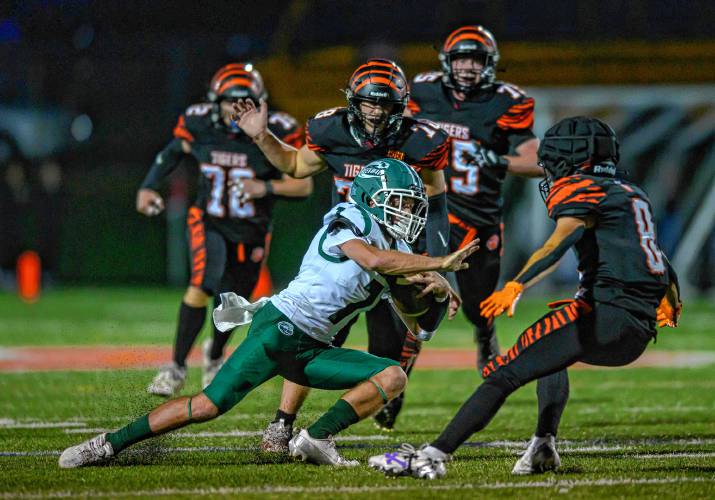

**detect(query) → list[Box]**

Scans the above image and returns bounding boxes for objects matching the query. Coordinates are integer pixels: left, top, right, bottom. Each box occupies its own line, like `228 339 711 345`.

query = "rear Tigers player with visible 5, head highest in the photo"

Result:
408 26 543 376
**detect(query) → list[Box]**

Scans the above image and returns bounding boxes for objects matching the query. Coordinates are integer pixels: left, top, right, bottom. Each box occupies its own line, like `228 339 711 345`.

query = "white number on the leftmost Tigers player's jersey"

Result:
201 163 256 219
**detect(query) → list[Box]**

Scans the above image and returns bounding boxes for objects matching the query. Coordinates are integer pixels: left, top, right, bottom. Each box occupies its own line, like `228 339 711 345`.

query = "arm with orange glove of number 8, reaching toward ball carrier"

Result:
480 217 591 318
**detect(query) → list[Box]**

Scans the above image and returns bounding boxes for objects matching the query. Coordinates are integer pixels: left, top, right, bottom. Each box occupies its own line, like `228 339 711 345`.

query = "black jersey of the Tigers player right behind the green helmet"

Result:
305 108 449 205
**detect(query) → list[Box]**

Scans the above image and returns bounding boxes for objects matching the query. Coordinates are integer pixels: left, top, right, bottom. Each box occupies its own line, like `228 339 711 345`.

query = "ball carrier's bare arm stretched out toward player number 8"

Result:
340 239 479 275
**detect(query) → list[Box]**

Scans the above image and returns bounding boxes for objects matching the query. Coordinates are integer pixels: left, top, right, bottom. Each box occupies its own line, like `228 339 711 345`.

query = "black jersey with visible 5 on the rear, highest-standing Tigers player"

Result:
408 72 535 226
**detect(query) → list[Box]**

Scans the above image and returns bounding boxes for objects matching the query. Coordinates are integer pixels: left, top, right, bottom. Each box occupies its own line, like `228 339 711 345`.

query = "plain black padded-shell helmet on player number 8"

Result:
537 116 619 200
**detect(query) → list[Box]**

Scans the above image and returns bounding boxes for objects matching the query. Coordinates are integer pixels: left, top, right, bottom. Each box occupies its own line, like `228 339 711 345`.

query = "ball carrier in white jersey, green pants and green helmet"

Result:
59 159 477 468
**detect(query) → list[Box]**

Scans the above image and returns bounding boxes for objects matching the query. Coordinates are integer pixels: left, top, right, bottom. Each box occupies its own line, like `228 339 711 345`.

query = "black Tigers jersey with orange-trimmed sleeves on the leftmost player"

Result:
174 103 303 245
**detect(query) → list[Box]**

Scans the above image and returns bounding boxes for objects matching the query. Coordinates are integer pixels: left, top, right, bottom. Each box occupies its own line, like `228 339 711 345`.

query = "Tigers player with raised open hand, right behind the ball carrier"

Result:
236 59 450 446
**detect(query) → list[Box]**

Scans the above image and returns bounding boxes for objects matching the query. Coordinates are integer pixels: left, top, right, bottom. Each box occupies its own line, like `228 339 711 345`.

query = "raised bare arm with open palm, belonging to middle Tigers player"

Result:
231 99 325 179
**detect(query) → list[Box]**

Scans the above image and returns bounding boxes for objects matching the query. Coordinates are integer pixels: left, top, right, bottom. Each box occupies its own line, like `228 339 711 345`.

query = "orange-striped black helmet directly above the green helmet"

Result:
345 59 409 145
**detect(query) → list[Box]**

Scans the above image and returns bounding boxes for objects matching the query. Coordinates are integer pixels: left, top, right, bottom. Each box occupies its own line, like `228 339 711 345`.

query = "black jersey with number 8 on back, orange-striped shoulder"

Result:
546 174 669 319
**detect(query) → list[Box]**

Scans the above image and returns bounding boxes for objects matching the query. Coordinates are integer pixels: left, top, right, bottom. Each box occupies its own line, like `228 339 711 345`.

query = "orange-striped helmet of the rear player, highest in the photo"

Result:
439 26 499 93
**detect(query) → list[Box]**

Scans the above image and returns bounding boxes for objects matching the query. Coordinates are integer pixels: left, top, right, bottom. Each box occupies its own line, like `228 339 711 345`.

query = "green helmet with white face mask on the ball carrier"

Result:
350 158 427 243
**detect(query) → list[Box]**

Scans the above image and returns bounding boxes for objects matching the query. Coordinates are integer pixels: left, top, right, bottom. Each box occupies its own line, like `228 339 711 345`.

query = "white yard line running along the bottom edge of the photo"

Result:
0 477 715 499
